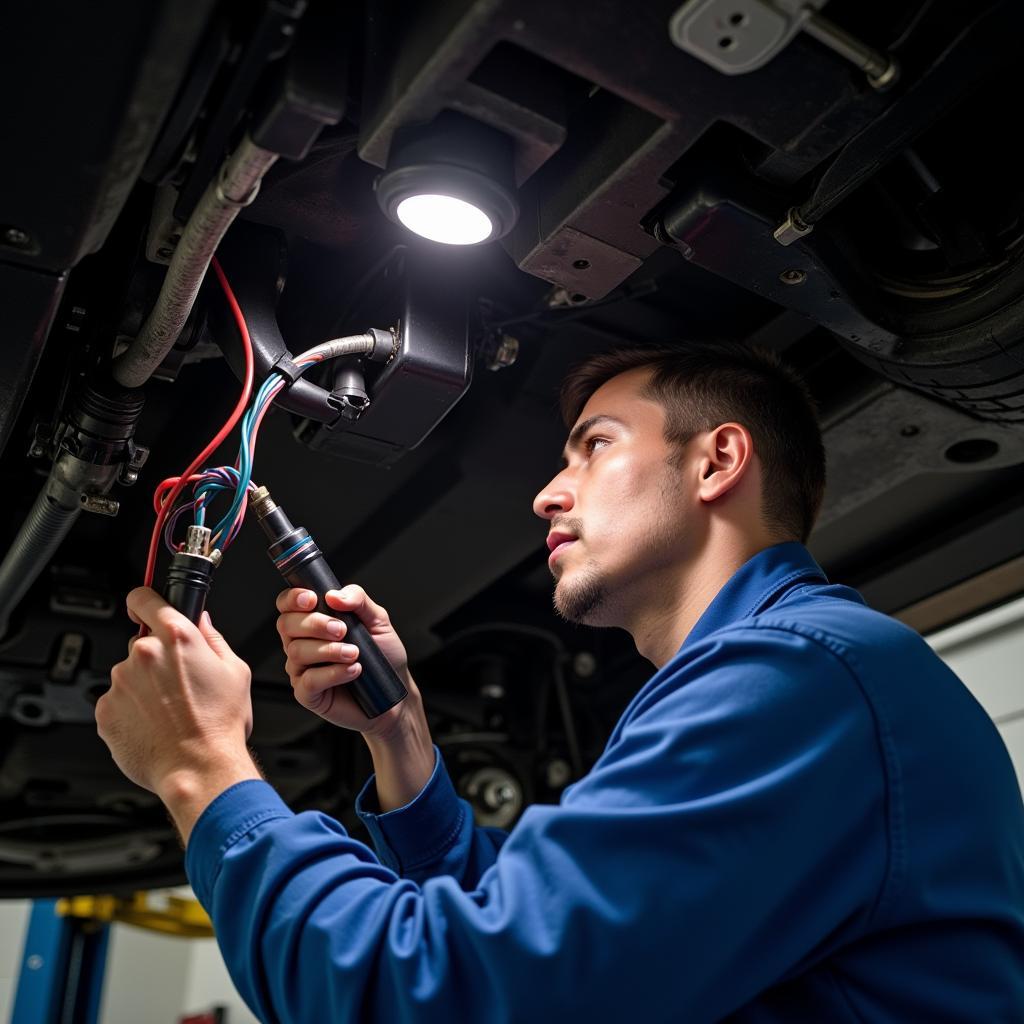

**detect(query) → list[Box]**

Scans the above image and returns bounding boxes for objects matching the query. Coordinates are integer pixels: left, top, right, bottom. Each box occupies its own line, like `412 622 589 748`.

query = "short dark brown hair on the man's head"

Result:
561 342 825 541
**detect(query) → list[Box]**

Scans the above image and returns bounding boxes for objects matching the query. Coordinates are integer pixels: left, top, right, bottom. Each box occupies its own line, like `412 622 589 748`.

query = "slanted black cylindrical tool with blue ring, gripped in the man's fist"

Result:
250 487 409 718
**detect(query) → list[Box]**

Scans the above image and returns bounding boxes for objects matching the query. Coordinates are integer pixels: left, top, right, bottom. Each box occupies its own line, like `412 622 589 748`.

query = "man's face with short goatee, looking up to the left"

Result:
534 369 693 626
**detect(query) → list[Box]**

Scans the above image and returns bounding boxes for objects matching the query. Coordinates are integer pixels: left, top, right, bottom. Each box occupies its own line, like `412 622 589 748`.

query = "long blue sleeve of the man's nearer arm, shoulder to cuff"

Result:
186 629 888 1024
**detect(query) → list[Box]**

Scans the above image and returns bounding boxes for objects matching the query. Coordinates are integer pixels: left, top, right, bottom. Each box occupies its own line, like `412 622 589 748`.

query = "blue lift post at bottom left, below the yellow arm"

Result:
10 899 111 1024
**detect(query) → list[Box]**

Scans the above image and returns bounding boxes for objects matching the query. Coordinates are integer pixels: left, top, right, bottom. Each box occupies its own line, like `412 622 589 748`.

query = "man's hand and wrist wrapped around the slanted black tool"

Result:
278 586 434 811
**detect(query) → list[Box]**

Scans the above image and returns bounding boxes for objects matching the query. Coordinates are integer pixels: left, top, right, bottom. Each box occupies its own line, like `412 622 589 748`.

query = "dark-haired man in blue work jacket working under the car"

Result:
96 345 1024 1022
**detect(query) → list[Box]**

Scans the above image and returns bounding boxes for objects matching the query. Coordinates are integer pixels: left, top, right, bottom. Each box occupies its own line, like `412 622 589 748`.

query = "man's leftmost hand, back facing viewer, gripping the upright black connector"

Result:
96 587 260 838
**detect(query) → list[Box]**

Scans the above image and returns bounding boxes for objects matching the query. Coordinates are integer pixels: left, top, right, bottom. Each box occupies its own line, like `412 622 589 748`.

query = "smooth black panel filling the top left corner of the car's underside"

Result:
0 0 214 271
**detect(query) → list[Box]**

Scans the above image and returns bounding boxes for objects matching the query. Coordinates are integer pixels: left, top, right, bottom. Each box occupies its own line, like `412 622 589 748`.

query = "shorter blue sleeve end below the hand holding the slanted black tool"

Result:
355 746 508 889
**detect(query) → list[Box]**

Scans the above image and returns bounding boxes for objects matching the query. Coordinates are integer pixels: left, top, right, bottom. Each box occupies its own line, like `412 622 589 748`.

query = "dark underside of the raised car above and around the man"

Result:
0 0 1024 897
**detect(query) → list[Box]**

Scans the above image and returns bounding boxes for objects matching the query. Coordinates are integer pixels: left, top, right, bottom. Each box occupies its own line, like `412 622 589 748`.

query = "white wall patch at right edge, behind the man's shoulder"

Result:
926 598 1024 790
